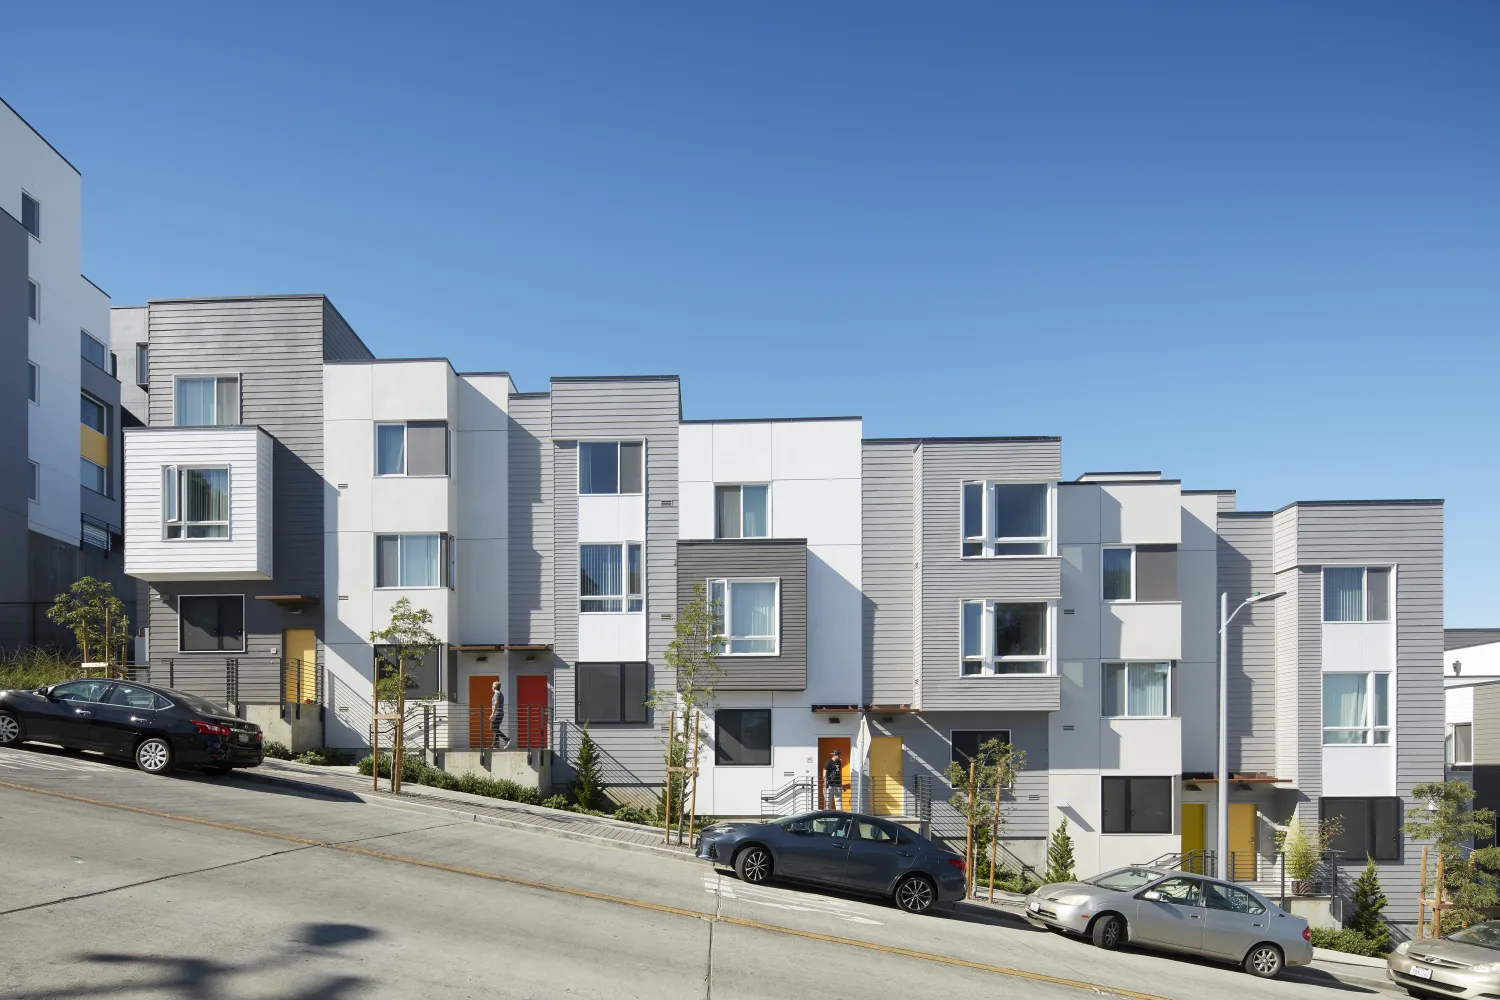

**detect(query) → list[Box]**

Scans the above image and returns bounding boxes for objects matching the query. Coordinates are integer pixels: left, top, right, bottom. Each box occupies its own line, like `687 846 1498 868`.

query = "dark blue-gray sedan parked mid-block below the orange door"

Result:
698 813 966 913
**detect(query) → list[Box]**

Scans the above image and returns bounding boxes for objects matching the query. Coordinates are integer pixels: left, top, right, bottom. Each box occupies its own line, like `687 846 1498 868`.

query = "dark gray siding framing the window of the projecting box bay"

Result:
677 540 807 691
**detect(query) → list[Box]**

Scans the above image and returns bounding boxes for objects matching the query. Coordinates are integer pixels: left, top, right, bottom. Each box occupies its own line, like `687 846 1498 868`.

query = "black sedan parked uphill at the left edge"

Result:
0 679 264 775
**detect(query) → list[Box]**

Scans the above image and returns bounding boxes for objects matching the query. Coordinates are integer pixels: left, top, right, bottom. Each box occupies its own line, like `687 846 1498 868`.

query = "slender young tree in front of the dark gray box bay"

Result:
651 583 725 843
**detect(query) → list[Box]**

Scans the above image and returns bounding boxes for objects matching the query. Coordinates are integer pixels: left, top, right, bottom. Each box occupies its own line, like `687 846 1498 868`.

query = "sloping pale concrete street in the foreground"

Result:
0 747 1383 1000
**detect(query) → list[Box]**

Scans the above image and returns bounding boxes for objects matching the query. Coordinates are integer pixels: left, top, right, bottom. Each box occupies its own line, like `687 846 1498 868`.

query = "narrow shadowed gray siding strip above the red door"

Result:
509 396 552 643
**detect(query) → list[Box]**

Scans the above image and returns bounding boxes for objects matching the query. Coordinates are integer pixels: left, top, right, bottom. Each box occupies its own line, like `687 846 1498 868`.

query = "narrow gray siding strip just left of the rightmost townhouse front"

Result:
1215 516 1280 777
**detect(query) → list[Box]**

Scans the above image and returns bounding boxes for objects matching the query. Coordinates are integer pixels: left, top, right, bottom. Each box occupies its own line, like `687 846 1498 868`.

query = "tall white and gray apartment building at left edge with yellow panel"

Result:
0 95 134 648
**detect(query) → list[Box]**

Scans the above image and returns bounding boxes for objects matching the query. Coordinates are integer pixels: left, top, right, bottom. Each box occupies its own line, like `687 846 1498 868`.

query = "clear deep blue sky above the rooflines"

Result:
0 0 1500 627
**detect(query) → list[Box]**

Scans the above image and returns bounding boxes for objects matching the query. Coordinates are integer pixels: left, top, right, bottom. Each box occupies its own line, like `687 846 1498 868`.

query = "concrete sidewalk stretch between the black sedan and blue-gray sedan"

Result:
249 757 696 864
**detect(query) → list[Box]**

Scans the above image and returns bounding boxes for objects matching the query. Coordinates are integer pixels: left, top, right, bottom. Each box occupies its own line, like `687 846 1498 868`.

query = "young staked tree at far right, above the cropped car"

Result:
1401 781 1500 934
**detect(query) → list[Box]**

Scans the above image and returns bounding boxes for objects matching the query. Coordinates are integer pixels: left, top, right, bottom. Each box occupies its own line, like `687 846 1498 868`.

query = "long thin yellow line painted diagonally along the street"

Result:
0 781 1167 1000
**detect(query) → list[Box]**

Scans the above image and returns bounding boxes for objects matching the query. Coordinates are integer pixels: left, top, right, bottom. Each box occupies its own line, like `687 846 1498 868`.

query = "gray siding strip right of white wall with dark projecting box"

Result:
861 442 917 705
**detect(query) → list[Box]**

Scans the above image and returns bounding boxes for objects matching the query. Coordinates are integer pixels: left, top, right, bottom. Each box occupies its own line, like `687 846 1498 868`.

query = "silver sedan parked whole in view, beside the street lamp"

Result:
1026 868 1313 979
